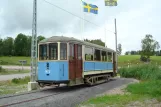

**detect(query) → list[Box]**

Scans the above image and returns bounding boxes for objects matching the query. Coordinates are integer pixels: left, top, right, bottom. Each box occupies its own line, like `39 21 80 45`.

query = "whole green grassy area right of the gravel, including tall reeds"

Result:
79 64 161 107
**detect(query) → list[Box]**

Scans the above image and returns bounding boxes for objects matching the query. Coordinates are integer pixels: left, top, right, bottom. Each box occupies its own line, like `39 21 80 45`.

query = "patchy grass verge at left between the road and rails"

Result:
0 77 30 95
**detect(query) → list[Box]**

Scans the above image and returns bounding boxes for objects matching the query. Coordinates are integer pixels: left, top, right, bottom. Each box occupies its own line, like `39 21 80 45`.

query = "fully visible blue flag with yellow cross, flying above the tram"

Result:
82 1 98 14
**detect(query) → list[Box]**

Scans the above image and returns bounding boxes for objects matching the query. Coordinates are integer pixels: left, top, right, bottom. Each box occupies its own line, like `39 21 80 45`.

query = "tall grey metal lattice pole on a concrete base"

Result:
28 0 37 91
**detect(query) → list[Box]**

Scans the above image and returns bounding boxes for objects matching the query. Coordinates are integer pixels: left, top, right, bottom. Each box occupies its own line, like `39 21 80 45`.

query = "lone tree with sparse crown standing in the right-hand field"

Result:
141 34 160 59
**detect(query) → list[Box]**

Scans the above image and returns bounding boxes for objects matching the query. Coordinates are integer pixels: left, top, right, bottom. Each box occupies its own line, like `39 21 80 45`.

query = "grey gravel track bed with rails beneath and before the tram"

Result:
0 78 134 107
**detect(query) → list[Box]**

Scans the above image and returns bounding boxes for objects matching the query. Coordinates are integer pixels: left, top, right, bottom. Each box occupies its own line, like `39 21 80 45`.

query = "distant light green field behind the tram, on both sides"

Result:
0 55 161 66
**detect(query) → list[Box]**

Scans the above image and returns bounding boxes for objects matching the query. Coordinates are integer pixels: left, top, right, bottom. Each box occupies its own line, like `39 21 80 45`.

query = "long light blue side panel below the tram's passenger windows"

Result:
84 61 113 72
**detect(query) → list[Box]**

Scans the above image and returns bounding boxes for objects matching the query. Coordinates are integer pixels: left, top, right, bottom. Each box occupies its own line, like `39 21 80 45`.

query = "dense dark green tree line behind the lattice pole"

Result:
0 33 45 56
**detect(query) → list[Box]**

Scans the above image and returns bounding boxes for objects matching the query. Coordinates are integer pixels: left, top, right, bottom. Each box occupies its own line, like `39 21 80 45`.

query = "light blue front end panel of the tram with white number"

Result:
38 61 69 81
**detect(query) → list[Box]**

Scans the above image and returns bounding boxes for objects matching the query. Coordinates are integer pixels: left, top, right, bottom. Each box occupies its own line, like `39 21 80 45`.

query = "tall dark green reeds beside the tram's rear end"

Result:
119 64 161 80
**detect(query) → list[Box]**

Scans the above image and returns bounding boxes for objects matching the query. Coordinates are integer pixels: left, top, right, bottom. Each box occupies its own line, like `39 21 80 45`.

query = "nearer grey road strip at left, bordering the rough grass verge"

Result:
0 73 30 81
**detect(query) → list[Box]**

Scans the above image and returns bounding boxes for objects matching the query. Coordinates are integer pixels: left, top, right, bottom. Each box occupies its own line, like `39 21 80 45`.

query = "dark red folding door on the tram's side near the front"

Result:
69 44 82 80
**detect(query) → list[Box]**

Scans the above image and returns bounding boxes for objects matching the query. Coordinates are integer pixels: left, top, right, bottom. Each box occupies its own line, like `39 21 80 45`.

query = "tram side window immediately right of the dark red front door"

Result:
84 47 94 61
